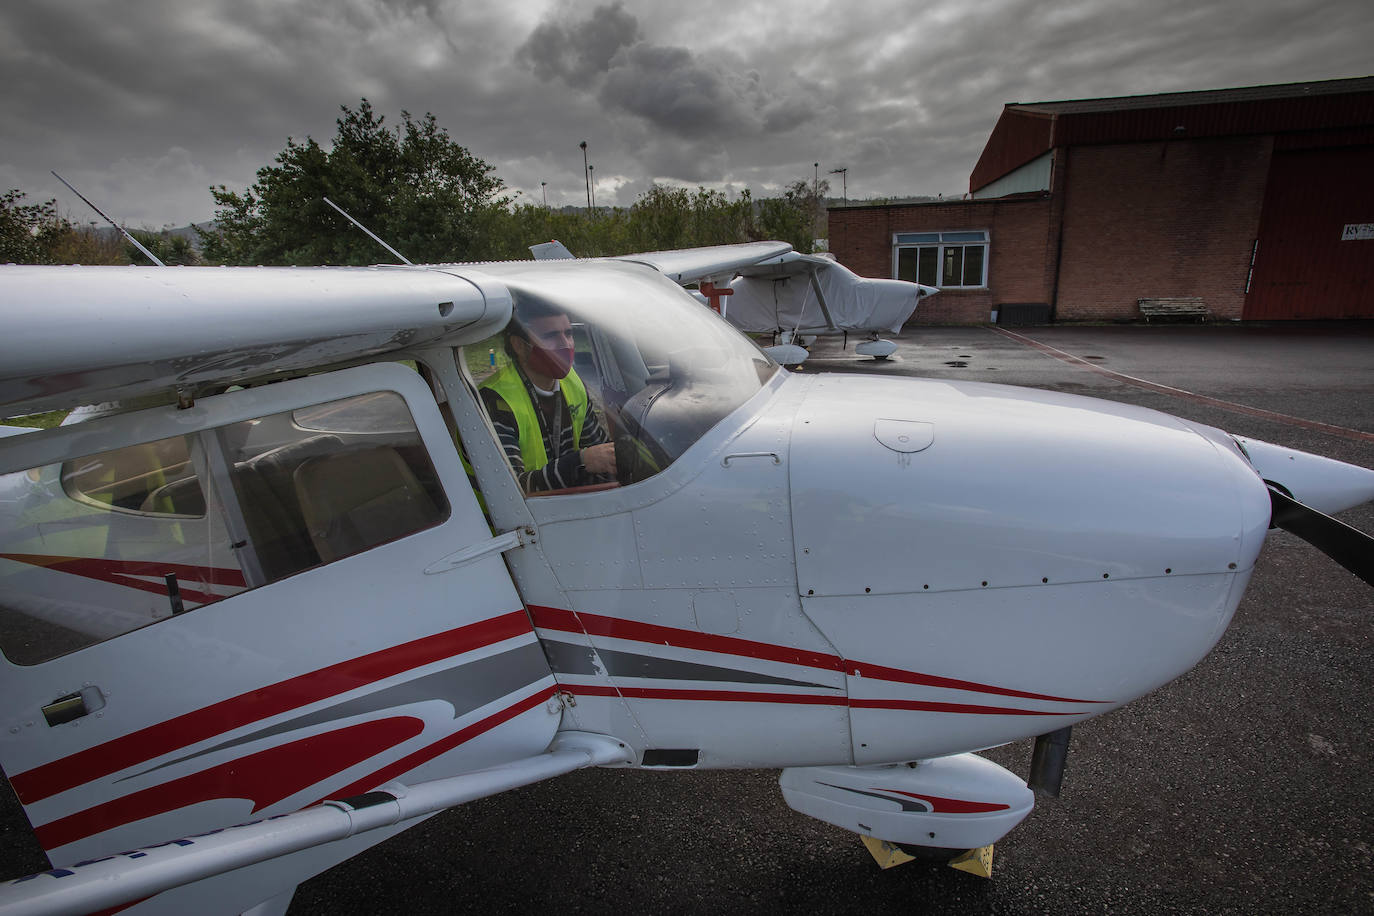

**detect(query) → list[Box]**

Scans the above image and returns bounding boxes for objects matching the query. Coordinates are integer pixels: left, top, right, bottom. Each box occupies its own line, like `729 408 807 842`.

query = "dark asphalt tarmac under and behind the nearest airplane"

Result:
0 323 1374 916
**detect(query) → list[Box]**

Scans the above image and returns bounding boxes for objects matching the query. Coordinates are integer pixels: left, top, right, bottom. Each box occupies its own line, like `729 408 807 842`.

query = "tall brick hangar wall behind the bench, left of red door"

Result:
1055 136 1272 321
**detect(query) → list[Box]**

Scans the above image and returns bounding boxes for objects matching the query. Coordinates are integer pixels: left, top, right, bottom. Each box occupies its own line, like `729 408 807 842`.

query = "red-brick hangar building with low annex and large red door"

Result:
829 77 1374 323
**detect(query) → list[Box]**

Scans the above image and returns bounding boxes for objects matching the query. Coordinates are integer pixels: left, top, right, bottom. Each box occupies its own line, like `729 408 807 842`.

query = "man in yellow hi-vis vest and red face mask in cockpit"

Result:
480 291 616 493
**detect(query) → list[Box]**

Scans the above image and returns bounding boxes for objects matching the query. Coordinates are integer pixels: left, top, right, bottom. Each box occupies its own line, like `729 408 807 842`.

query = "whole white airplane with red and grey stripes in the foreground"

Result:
0 243 1374 916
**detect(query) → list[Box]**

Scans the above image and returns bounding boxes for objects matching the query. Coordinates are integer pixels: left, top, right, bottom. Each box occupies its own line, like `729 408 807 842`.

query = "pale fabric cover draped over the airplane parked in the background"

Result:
725 253 938 334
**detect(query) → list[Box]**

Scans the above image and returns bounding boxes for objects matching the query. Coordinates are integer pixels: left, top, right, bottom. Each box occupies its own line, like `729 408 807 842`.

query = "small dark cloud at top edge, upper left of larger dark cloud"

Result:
515 3 639 88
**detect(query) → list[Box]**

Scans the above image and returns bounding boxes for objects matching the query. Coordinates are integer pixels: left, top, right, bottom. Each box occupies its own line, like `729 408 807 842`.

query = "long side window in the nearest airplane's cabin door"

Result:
0 391 449 665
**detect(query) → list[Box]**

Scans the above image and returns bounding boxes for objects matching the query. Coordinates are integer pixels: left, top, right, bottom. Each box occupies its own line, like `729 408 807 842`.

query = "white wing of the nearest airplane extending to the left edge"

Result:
0 259 511 416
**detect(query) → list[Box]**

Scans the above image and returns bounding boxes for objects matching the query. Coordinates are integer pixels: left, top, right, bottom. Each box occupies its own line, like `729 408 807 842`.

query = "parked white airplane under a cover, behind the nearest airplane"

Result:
529 239 940 365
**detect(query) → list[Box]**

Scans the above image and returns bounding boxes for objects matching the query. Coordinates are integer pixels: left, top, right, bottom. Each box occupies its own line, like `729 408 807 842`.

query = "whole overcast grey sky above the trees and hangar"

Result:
0 0 1374 228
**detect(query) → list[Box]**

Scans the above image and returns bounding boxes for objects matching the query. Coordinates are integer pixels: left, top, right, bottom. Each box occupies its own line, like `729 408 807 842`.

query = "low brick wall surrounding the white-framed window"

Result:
829 198 1057 324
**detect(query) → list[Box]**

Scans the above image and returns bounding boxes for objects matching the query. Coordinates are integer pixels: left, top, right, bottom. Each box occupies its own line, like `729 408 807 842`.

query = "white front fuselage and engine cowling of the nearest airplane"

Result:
514 375 1268 766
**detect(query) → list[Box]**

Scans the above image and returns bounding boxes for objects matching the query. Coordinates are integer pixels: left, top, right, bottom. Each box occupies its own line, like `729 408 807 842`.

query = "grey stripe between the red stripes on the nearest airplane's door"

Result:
115 643 548 781
